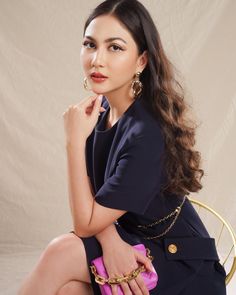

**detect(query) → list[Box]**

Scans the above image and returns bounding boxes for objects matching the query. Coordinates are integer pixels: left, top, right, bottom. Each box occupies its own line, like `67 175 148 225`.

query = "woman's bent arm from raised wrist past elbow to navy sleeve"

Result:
66 139 127 237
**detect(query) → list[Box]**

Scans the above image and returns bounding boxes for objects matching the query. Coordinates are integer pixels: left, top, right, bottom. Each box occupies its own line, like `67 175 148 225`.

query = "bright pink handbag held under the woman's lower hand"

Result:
90 244 158 295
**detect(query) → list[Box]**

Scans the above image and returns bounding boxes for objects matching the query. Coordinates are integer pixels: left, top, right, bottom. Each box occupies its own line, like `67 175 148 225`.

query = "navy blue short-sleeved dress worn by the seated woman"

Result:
71 96 226 295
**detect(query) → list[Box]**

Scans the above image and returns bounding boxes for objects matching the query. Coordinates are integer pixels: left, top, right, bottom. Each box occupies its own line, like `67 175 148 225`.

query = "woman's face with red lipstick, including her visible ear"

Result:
80 15 146 95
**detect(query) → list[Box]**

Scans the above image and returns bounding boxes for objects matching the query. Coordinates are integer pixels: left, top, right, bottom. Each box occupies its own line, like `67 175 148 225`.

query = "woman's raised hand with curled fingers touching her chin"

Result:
63 95 105 144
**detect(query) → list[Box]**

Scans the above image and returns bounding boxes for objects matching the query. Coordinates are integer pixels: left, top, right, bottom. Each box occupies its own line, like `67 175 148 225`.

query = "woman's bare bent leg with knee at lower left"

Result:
18 233 91 295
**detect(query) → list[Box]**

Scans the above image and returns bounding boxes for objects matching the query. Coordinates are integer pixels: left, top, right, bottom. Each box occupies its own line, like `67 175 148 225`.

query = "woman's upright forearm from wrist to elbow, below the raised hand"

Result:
66 141 94 234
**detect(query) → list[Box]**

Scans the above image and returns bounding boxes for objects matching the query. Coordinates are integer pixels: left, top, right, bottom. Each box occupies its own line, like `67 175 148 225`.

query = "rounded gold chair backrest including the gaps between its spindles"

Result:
189 197 236 285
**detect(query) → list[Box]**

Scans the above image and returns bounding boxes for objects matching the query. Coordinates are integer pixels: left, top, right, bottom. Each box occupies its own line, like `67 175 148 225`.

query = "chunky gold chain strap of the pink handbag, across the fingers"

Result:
90 248 154 285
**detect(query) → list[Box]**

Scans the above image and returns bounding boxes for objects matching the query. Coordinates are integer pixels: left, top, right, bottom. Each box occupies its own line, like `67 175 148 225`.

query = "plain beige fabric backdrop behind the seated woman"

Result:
0 0 236 294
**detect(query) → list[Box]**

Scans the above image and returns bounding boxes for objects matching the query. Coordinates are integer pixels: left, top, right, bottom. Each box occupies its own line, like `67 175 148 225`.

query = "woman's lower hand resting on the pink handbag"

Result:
103 240 153 295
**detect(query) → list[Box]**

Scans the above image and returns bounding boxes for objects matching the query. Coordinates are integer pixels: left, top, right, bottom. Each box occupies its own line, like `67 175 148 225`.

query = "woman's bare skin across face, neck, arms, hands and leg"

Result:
18 15 152 295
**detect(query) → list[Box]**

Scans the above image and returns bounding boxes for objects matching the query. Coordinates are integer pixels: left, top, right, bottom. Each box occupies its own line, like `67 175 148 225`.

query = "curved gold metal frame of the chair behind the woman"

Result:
189 198 236 285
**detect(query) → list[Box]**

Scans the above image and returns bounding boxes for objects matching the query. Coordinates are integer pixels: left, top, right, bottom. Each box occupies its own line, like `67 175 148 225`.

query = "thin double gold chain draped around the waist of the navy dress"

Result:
137 196 186 240
